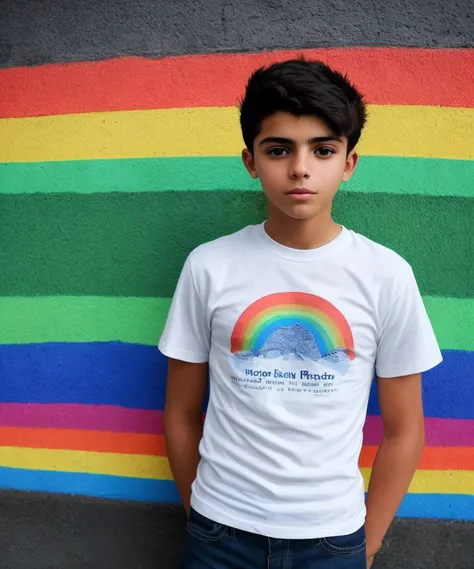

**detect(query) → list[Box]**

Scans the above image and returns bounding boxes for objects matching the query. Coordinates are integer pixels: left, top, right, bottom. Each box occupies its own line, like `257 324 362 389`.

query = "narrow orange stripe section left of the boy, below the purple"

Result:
0 427 166 456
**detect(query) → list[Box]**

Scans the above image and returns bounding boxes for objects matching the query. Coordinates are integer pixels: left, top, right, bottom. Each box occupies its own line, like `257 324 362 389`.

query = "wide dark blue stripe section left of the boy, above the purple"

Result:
0 342 167 410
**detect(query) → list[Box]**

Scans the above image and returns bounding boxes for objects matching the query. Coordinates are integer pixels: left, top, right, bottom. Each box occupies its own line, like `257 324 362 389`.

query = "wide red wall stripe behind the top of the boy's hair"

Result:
0 47 474 117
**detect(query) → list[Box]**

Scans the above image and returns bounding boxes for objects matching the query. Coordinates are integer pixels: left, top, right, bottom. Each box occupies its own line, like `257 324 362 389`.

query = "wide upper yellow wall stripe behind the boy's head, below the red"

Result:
0 105 474 162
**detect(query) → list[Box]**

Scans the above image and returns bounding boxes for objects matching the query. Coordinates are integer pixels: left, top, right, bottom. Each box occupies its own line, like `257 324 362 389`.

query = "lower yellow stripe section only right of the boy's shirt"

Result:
361 468 474 495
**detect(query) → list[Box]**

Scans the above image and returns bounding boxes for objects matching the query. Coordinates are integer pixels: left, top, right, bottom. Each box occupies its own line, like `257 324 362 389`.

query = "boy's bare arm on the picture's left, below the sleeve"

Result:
164 359 208 514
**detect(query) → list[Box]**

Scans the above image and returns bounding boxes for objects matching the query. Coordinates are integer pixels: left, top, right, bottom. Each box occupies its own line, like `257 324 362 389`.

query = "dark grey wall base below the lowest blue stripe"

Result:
0 491 474 569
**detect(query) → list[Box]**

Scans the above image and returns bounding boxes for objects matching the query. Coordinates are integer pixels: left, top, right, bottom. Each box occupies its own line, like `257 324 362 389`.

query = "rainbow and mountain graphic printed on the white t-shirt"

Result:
230 292 355 373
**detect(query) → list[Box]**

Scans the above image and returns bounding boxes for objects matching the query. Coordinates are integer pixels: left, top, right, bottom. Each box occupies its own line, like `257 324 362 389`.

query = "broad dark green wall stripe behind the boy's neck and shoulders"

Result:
0 191 474 297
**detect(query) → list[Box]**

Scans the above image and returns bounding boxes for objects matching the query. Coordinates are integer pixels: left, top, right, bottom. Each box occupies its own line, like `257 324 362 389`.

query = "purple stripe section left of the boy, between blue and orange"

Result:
0 403 163 435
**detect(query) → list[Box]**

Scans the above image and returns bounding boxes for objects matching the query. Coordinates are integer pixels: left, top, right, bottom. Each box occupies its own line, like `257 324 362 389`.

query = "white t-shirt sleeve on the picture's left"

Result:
158 252 210 363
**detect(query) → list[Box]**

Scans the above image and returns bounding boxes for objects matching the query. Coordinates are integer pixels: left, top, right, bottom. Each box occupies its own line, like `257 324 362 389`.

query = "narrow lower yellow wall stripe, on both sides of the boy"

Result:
0 447 474 495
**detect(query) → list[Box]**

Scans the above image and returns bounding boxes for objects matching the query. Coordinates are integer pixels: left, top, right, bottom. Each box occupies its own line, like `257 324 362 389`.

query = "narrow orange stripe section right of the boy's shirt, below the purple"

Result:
359 446 474 470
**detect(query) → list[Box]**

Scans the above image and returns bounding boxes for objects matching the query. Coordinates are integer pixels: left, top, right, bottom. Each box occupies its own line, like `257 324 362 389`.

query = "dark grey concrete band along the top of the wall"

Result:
0 0 474 65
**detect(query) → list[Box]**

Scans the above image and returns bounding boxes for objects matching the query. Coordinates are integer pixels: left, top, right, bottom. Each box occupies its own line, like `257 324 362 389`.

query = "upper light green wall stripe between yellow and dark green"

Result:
0 156 474 197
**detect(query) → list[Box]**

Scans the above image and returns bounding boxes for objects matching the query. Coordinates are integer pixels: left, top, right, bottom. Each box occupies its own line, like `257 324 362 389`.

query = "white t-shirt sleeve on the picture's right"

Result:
375 268 443 377
